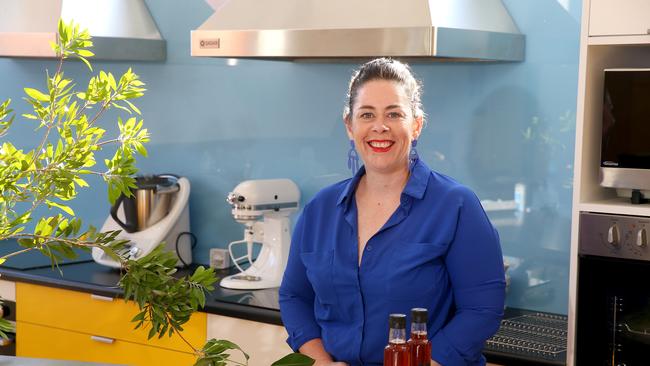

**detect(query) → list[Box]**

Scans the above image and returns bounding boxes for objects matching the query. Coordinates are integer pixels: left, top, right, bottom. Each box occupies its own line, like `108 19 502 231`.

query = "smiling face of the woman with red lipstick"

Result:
345 80 422 173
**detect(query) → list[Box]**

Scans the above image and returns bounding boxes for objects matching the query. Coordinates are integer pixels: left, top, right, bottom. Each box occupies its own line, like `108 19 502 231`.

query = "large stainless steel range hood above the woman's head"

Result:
192 0 525 61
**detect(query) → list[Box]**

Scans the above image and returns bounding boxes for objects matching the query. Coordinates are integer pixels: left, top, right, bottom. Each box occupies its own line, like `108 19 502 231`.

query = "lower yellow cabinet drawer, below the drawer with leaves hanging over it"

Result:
16 322 196 366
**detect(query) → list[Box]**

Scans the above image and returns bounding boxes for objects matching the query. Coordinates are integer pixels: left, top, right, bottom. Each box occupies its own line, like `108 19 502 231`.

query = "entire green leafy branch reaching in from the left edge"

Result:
0 21 313 366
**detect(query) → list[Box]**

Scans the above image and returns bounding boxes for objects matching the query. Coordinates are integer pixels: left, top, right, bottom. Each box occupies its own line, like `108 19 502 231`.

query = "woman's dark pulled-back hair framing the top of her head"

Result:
343 57 424 119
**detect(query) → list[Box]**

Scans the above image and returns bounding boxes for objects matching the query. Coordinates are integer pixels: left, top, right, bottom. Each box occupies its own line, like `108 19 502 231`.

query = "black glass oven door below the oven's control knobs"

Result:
575 255 650 366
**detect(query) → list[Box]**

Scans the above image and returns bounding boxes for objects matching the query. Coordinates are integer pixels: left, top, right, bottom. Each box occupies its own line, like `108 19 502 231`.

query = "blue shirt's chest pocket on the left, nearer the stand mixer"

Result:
300 250 337 308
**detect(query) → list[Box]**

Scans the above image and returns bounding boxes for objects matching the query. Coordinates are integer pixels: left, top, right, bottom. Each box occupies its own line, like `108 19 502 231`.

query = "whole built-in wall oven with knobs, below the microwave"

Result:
575 212 650 366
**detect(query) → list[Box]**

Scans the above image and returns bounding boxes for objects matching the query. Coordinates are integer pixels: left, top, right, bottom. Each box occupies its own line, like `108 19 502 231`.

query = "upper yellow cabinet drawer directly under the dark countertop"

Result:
16 282 207 352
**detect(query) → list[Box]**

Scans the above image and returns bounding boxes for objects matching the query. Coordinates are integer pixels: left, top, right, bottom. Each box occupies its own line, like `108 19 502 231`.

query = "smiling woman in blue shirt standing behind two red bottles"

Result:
280 58 505 366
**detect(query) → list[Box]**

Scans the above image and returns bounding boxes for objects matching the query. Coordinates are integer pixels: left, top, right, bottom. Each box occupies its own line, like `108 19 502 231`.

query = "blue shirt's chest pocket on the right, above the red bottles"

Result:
386 243 447 300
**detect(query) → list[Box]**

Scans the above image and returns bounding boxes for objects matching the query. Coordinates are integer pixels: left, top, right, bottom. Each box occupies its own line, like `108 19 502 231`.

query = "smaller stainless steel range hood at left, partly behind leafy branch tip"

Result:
0 0 166 61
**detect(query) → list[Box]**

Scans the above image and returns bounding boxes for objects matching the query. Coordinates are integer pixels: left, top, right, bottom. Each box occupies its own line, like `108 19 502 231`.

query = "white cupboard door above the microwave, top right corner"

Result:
589 0 650 36
